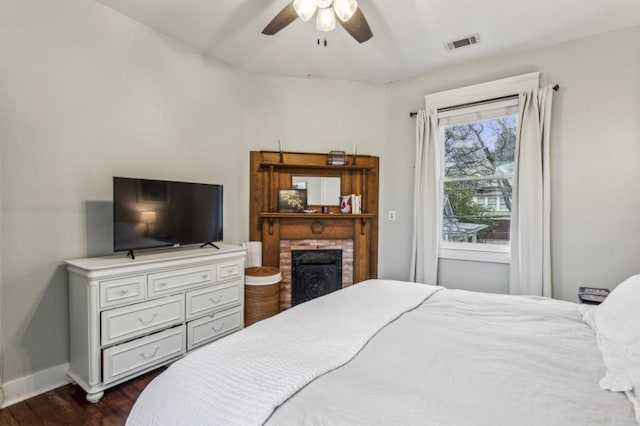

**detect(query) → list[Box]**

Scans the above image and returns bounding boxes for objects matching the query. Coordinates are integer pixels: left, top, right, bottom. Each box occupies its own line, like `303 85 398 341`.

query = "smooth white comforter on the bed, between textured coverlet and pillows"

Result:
268 290 636 426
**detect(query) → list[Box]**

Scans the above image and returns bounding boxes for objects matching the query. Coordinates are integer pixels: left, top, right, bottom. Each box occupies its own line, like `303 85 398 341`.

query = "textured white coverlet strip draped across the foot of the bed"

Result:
127 280 441 426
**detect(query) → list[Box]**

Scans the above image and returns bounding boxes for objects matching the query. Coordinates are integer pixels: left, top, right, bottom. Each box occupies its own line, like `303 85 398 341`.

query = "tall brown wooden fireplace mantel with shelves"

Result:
249 151 379 283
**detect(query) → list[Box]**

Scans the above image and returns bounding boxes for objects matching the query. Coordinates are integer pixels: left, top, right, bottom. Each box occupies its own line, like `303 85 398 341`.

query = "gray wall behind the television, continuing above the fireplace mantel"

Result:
0 0 385 382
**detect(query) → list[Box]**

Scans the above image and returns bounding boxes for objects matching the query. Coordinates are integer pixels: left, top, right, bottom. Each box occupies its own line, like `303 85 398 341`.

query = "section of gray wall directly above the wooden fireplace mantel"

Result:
247 75 386 161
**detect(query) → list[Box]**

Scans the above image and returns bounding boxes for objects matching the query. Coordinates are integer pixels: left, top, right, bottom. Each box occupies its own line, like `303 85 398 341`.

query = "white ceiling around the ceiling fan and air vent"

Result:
98 0 640 82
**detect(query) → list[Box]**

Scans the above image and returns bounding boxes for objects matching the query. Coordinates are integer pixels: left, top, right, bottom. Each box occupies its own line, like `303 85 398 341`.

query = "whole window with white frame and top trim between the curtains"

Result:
425 73 539 263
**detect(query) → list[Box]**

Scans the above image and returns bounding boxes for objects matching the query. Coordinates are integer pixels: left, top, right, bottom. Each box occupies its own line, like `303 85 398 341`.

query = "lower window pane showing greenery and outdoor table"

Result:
442 178 512 244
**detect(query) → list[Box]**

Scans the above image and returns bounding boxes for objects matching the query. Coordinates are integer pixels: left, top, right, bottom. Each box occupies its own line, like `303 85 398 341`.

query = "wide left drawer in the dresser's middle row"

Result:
100 294 184 346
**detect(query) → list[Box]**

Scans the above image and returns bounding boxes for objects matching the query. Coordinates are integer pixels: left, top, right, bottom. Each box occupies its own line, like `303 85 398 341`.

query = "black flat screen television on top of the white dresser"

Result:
113 177 222 257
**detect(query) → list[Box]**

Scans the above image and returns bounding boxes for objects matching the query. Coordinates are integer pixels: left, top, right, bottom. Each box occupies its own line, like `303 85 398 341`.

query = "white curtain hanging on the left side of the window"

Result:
409 110 442 284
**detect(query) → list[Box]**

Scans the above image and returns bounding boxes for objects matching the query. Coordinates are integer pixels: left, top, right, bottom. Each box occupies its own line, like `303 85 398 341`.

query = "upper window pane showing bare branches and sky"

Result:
442 115 517 179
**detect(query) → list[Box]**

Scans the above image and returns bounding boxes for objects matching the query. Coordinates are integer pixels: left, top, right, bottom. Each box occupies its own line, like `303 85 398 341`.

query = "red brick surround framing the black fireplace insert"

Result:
279 239 353 310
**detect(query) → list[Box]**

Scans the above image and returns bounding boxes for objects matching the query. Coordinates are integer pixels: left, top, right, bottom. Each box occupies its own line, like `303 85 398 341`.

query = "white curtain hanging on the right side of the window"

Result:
509 86 553 297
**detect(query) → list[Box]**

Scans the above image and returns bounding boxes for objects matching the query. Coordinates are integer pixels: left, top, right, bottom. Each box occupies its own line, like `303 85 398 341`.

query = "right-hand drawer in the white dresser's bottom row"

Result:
187 306 242 350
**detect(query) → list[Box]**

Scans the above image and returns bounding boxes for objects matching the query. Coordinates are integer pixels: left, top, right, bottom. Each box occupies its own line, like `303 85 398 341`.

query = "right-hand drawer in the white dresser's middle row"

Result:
186 281 242 319
